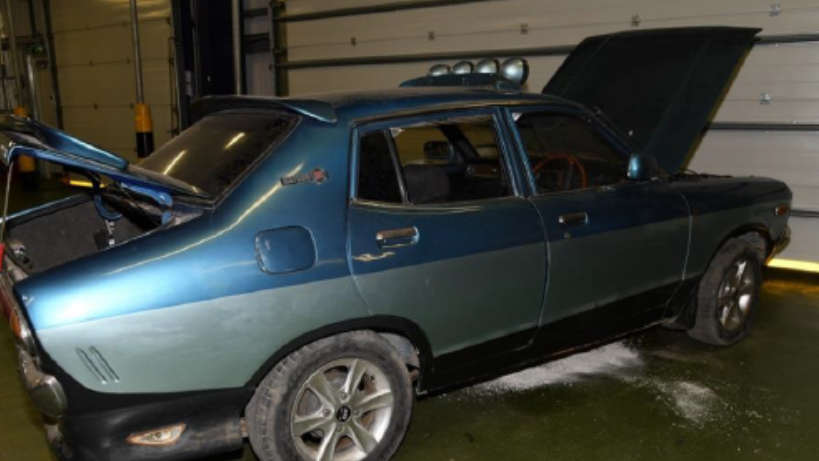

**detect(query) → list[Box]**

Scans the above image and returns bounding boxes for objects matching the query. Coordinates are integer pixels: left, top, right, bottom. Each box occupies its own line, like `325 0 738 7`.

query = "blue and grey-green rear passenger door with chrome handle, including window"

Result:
348 109 546 368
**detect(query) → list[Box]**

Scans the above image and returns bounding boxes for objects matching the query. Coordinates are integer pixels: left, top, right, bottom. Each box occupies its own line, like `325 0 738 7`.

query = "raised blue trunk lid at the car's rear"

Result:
0 116 208 198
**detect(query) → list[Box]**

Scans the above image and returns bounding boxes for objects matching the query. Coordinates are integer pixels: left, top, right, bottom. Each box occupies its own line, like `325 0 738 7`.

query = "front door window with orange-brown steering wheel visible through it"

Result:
516 113 628 194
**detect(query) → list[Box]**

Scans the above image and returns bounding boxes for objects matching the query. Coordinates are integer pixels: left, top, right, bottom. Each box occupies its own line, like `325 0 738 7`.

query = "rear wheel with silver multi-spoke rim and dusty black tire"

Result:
245 331 413 461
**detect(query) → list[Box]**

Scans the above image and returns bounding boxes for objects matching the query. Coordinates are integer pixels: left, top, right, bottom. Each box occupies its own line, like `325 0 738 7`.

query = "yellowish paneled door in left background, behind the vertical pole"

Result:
51 0 173 161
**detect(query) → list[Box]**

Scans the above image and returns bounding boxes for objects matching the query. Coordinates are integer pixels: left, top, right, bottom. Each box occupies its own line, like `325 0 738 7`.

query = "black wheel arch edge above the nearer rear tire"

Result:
246 316 433 388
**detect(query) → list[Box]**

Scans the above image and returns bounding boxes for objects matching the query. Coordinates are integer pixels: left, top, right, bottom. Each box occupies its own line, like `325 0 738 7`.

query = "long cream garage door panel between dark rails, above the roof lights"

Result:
288 1 819 60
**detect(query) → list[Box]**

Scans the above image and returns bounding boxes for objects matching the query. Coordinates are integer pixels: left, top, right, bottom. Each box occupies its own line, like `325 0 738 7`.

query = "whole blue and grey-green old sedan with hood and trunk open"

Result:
0 28 792 461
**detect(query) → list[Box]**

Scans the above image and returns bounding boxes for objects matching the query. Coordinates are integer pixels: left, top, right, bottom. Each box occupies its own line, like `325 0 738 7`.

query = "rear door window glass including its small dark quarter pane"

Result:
358 117 512 205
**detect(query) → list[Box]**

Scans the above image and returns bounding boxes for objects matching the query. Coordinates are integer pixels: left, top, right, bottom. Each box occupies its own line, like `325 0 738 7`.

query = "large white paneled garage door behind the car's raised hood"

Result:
251 0 819 262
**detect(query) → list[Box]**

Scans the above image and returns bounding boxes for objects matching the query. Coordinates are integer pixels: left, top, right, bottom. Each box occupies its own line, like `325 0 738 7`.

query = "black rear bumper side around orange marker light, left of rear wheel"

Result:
46 389 248 461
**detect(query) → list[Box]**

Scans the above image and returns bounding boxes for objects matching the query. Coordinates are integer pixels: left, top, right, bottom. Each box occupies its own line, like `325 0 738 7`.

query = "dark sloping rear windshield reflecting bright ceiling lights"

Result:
139 112 295 197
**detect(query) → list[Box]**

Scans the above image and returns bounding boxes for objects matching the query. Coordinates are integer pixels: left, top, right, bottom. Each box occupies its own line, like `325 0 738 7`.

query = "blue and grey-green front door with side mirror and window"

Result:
510 109 689 345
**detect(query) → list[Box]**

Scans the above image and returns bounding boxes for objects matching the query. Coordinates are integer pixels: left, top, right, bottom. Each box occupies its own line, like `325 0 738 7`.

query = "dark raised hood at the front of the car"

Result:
543 27 760 172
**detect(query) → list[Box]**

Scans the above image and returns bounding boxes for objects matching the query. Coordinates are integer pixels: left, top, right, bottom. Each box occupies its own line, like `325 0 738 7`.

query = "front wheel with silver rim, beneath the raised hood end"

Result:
688 239 762 346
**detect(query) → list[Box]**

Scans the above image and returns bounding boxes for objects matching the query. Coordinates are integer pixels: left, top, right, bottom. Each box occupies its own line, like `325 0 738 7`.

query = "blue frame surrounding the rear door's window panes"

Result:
349 106 525 210
